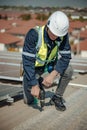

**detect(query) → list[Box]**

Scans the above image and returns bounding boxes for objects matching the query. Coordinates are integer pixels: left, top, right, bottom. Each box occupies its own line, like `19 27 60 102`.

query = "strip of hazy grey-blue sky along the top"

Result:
0 0 87 8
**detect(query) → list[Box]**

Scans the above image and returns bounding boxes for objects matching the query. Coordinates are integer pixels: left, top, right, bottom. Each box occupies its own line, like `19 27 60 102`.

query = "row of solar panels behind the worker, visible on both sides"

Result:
0 52 87 81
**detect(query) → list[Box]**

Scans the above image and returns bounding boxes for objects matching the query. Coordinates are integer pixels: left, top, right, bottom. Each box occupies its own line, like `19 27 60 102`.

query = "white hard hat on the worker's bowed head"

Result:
47 11 69 36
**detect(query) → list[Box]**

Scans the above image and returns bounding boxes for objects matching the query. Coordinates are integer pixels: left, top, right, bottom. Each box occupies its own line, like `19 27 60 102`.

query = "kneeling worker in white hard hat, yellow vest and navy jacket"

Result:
22 11 73 111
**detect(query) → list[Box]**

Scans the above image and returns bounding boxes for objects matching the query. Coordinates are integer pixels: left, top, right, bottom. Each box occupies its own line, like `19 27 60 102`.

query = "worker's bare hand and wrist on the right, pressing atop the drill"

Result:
42 70 58 87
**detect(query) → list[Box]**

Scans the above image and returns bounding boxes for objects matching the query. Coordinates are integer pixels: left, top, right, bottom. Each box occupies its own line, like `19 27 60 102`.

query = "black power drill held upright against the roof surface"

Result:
38 77 45 110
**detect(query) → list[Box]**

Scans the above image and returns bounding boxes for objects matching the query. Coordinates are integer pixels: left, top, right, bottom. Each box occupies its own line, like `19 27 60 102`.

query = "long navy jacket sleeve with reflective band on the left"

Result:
22 29 38 86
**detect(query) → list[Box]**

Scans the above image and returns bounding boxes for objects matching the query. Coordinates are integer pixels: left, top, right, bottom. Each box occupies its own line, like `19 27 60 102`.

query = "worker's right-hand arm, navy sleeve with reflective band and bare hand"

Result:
43 34 71 87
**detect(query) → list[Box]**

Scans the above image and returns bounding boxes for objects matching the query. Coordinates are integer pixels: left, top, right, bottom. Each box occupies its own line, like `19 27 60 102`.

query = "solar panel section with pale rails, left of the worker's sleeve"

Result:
0 52 22 81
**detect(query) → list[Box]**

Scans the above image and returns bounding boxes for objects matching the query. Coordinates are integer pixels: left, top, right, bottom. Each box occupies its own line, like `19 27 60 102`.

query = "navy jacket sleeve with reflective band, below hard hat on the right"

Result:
55 34 71 74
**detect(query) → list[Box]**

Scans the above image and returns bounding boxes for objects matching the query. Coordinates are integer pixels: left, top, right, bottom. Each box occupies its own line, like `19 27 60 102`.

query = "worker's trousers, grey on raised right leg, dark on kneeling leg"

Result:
23 65 73 104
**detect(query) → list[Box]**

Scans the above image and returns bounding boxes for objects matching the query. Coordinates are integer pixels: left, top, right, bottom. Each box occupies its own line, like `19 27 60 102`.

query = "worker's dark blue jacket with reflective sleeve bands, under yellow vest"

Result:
22 25 71 86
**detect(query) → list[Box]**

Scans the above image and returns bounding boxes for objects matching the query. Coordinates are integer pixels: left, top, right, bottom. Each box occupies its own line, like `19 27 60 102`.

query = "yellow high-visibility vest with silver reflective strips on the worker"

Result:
35 26 63 67
